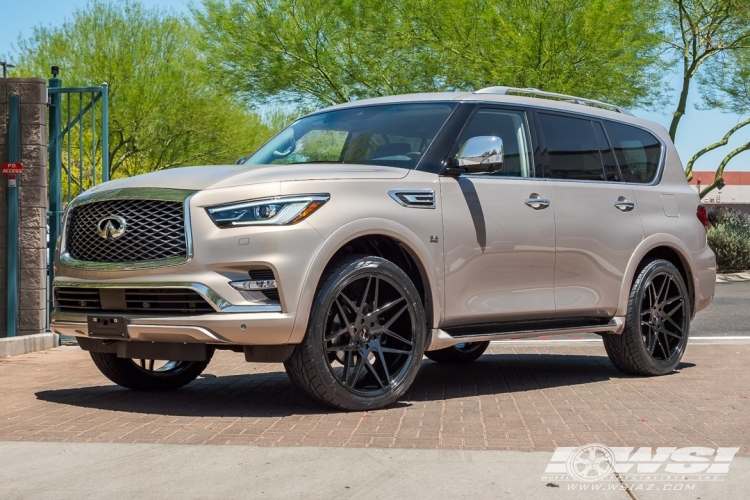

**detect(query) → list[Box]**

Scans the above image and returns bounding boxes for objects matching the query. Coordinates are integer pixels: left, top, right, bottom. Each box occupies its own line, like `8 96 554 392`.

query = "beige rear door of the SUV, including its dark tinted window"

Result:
536 111 643 318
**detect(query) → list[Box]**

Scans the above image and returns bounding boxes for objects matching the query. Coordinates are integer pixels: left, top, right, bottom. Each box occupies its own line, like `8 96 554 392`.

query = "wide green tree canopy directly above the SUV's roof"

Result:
193 0 661 107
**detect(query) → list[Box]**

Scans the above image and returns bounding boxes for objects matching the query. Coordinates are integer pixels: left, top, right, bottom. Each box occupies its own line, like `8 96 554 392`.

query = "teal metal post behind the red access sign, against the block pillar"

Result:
5 95 21 337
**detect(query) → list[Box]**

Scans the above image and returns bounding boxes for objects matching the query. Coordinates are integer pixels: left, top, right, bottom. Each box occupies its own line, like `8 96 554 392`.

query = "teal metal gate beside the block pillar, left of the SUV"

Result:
47 72 110 316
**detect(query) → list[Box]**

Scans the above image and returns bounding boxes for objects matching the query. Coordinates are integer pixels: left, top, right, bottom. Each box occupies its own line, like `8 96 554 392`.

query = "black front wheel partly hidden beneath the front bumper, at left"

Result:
89 349 213 391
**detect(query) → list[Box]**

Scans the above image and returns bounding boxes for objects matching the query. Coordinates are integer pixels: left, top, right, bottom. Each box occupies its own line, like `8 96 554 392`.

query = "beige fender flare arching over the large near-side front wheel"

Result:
289 219 442 344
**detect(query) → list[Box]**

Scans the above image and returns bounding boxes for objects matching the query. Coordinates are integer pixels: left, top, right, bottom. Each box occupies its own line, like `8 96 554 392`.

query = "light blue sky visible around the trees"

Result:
0 0 750 172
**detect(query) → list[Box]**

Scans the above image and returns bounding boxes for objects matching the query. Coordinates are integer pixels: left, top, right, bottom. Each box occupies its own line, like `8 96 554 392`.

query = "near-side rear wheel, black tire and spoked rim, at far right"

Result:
602 259 691 376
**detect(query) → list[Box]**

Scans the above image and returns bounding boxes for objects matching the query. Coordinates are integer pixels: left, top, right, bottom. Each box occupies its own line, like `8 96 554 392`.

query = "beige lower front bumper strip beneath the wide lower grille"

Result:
50 309 294 345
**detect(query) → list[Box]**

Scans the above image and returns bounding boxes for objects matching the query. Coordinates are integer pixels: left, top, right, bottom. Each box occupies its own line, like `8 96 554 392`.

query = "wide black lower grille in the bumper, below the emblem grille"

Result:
55 287 215 314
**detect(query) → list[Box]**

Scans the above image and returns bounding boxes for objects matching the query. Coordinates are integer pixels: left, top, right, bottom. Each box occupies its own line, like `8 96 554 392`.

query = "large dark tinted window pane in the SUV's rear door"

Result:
539 113 605 181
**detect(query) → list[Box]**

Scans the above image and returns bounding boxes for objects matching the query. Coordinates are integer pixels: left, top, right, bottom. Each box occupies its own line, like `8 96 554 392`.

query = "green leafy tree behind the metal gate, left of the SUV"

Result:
15 0 269 189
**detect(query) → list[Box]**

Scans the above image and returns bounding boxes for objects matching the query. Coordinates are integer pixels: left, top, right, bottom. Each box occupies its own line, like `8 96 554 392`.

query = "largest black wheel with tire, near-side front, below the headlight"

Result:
284 256 427 411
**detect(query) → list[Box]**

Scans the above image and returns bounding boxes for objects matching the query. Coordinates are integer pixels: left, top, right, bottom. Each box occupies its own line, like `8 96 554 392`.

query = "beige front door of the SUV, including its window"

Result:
440 107 555 328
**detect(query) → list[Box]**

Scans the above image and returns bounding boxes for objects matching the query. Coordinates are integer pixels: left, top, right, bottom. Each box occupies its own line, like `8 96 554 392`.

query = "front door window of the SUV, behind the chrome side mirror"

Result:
458 108 534 177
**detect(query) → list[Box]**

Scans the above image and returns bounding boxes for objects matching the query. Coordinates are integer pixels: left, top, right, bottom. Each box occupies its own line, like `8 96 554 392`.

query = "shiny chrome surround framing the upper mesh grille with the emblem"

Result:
60 188 197 271
